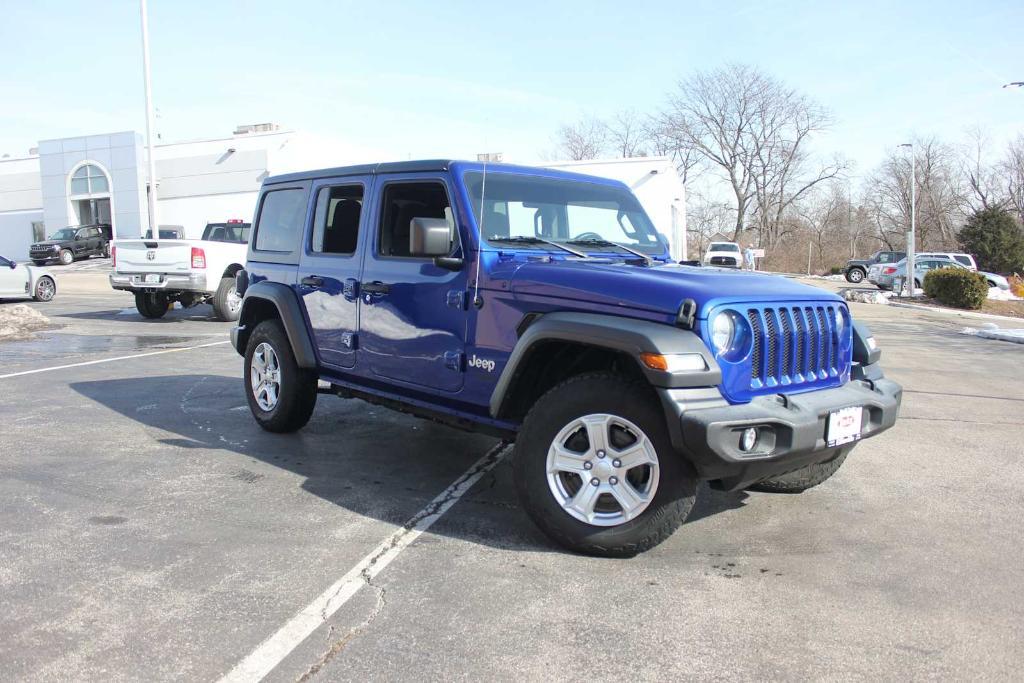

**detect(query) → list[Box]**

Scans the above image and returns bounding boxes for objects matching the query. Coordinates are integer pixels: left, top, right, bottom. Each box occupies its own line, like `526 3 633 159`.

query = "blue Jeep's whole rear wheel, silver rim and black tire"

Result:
243 319 316 432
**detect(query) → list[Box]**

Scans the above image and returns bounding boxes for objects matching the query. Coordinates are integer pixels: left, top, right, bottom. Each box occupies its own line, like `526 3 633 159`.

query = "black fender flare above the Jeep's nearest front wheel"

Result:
489 312 722 417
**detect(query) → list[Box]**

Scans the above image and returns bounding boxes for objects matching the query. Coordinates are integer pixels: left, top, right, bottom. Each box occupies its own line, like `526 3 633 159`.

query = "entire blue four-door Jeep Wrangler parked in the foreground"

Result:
231 161 901 556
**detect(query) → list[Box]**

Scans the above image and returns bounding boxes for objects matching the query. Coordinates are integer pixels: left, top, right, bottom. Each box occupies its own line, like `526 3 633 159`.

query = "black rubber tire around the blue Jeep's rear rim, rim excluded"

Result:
242 318 316 433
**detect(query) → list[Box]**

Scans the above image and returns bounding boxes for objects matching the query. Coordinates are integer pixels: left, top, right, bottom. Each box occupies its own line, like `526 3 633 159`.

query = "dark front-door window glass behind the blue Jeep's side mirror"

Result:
378 182 455 258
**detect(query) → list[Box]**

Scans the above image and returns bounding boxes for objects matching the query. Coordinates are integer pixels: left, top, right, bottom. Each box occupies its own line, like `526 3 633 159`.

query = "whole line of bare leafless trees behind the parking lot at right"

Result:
553 65 1024 270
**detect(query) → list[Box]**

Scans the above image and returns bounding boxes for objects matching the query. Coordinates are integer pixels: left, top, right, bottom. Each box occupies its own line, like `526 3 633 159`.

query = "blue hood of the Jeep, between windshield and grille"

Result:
496 260 842 317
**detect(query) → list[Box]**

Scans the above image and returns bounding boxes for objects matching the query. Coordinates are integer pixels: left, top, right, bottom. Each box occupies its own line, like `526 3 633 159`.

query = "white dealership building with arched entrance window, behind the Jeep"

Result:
0 124 685 260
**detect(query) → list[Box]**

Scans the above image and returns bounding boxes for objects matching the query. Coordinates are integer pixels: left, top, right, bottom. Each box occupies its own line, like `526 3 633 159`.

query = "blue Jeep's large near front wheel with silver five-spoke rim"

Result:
514 373 696 557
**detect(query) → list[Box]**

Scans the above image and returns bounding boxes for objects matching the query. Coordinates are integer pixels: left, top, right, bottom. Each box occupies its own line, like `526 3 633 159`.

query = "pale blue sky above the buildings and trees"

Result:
0 0 1024 178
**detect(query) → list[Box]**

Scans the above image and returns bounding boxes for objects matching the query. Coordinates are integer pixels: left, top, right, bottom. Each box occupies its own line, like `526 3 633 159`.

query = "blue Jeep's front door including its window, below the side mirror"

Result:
359 173 466 392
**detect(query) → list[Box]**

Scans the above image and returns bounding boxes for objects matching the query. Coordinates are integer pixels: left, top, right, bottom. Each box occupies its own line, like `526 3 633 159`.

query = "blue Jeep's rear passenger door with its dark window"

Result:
298 176 371 369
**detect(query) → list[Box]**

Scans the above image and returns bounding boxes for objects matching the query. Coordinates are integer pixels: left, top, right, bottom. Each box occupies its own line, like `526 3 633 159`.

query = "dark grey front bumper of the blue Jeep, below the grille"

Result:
659 373 903 490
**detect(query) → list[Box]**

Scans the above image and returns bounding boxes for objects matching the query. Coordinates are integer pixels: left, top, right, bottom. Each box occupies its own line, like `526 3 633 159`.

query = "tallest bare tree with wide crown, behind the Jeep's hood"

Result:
658 65 843 243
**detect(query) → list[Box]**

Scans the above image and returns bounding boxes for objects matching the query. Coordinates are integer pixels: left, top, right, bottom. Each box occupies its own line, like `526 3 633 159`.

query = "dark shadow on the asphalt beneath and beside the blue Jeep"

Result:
70 375 745 552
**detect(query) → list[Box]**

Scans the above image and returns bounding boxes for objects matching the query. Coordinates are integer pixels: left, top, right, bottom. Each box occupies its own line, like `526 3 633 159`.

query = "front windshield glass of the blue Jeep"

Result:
465 171 665 254
